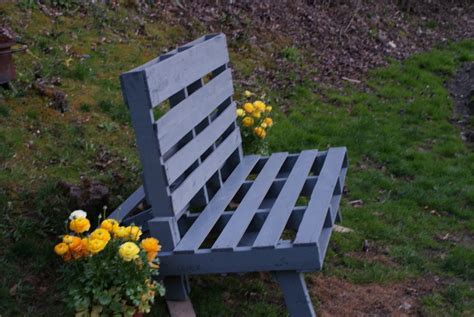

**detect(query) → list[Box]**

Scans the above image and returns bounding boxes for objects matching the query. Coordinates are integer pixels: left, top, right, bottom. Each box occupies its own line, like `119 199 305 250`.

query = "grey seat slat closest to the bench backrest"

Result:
174 155 259 253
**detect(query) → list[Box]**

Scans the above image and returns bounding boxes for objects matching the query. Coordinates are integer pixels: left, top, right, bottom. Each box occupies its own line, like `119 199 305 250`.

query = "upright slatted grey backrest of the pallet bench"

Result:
120 34 242 216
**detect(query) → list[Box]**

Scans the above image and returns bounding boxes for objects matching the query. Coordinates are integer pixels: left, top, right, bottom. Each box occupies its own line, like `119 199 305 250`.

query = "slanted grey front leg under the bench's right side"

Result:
272 271 316 317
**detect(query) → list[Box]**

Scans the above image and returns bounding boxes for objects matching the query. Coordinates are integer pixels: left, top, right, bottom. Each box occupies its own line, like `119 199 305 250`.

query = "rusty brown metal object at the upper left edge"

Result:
0 28 26 84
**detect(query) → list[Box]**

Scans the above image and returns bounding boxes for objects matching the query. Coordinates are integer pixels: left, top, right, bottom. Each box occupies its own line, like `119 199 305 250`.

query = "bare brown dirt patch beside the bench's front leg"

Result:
310 274 441 316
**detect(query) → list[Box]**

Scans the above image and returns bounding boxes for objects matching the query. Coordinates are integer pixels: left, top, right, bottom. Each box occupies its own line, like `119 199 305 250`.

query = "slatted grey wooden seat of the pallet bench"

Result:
111 147 347 276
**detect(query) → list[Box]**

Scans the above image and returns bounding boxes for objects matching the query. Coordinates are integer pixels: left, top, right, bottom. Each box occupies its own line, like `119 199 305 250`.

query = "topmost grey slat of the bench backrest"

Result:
142 34 229 106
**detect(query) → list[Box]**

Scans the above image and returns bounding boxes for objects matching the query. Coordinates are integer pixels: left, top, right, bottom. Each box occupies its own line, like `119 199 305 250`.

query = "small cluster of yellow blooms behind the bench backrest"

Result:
237 90 273 139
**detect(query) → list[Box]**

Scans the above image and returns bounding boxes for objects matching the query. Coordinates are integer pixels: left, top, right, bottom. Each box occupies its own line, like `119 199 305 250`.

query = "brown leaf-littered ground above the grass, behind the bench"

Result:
153 0 474 89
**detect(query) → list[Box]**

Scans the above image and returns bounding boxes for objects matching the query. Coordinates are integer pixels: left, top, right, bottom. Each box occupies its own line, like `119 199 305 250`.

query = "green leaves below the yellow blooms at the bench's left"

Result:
62 239 164 316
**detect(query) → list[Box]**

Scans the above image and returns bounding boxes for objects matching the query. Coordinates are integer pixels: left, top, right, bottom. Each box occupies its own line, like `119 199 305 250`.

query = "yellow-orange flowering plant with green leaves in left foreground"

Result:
54 210 164 316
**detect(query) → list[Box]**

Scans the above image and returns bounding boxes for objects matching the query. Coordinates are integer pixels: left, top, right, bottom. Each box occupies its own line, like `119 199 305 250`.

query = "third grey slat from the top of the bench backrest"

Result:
164 103 236 184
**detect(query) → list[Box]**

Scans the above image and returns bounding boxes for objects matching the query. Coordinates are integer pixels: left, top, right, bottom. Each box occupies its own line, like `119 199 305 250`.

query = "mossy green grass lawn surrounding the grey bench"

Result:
0 4 474 316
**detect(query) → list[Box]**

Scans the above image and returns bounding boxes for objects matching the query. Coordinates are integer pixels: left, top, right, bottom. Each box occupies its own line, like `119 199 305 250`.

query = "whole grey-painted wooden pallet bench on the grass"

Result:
110 34 348 317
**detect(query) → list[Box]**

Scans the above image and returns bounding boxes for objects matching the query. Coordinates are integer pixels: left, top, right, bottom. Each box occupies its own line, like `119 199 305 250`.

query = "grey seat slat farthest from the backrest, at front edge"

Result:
294 147 346 245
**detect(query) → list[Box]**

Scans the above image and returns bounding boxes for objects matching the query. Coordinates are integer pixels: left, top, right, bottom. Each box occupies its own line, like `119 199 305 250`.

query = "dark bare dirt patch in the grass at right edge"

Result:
448 62 474 145
